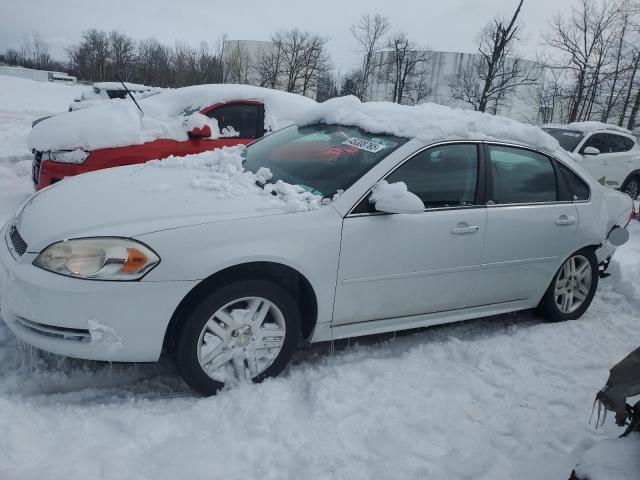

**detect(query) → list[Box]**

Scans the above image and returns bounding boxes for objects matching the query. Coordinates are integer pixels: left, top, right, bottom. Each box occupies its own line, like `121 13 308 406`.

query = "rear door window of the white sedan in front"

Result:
488 145 557 204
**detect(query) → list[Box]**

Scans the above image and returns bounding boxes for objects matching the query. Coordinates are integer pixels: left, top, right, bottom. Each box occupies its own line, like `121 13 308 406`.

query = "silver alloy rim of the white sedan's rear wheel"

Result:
554 255 593 314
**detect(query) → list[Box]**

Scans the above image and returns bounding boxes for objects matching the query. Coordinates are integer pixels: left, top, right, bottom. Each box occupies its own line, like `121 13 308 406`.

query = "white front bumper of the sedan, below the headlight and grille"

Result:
0 227 197 362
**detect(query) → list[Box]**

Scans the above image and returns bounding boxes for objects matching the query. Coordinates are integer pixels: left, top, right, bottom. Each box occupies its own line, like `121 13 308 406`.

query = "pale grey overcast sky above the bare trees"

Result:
0 0 576 72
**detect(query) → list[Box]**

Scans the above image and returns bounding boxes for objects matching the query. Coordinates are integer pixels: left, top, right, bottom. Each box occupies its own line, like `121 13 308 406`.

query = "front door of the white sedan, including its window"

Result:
333 143 486 325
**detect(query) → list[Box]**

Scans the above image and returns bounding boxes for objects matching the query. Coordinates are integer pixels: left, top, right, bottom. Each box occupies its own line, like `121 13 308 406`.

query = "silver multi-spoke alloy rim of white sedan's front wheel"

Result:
197 297 286 382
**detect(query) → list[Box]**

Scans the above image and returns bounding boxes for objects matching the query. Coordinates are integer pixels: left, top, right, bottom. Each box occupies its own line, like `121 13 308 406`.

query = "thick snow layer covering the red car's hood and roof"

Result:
27 84 316 151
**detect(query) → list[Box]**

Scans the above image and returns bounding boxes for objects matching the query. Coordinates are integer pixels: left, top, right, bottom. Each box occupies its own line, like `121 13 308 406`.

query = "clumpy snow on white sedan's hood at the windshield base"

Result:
145 145 322 212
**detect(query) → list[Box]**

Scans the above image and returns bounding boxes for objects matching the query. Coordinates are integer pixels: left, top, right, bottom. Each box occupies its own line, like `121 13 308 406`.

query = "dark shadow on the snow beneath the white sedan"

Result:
0 312 544 404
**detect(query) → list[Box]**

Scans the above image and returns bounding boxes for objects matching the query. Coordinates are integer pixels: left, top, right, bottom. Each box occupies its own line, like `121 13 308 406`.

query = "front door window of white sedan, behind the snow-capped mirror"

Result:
386 143 478 208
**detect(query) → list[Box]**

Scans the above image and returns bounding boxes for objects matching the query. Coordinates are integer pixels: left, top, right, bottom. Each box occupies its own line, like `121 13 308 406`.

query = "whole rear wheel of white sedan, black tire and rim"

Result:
536 248 599 322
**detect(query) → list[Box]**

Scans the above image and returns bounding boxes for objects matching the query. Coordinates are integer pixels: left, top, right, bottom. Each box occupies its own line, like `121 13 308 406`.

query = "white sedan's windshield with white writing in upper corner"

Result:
244 125 407 197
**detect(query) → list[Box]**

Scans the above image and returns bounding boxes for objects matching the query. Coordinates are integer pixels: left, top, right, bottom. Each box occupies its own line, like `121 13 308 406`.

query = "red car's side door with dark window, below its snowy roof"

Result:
178 101 264 155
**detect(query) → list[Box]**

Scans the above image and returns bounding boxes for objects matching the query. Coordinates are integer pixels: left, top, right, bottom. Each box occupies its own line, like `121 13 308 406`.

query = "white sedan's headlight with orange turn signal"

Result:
33 237 160 280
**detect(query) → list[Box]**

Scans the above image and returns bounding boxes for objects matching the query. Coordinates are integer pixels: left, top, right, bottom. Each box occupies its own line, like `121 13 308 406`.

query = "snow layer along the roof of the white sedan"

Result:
297 96 561 157
